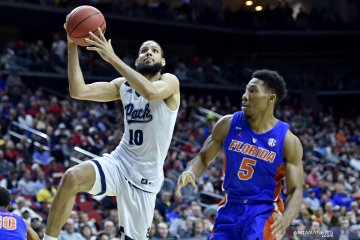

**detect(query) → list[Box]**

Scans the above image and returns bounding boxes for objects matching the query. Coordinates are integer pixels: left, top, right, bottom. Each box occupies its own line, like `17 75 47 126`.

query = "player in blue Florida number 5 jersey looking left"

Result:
176 70 303 240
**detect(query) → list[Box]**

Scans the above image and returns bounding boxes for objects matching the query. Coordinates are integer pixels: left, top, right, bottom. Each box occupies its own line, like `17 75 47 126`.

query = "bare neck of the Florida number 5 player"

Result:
247 113 278 134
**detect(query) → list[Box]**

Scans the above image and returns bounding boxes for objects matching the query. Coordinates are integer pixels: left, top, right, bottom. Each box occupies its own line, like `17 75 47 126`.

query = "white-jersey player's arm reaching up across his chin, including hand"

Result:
85 28 179 102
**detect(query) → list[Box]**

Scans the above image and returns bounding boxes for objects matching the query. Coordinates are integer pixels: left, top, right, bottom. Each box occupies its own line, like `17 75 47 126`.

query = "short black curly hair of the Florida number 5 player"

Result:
251 69 287 105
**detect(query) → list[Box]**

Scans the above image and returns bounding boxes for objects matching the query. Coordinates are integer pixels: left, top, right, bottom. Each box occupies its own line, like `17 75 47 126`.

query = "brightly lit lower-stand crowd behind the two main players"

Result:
0 68 360 240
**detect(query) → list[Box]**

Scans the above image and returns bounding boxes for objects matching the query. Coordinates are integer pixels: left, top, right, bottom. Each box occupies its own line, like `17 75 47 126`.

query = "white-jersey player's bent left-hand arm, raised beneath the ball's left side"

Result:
64 24 125 102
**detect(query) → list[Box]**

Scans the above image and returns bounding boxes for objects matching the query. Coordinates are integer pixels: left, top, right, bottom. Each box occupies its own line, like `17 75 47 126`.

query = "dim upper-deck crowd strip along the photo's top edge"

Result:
8 0 360 30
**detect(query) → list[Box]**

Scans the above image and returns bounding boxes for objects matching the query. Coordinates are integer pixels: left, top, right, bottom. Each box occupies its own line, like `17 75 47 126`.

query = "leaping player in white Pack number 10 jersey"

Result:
44 26 180 240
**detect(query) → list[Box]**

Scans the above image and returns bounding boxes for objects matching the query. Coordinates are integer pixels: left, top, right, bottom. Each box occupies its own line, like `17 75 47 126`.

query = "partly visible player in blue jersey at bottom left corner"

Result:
0 187 40 240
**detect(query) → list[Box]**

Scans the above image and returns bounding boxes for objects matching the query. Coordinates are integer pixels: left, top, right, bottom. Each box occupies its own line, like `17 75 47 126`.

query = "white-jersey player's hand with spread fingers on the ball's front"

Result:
85 28 116 62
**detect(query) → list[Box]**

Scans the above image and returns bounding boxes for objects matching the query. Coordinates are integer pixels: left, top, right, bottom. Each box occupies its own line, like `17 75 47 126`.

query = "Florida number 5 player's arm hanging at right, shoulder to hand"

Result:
272 130 304 238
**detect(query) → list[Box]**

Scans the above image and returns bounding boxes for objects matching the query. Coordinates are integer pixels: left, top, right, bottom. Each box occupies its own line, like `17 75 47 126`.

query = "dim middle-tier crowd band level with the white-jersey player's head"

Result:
0 33 360 91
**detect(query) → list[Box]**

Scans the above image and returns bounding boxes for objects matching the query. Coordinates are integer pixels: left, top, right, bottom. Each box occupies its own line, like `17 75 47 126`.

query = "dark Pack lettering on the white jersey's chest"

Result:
125 103 153 124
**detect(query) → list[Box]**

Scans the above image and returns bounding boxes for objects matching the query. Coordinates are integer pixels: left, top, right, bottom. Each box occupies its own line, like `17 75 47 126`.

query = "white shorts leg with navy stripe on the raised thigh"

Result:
86 156 122 196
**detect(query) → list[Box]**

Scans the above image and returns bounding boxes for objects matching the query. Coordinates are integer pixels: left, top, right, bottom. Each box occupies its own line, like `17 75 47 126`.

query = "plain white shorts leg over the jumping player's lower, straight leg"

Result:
117 181 156 240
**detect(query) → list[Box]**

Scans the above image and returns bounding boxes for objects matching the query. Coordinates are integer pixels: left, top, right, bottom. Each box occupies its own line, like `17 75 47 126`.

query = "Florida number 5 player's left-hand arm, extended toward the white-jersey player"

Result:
176 115 232 195
